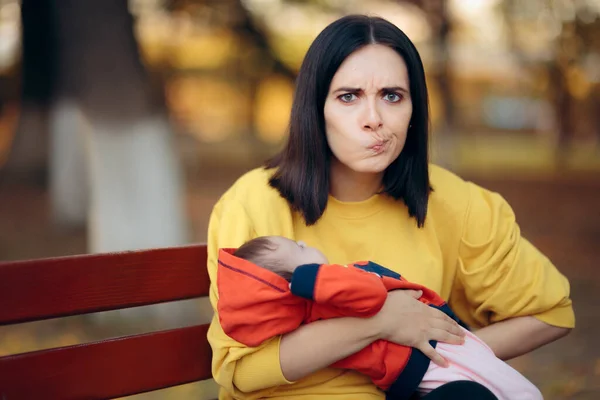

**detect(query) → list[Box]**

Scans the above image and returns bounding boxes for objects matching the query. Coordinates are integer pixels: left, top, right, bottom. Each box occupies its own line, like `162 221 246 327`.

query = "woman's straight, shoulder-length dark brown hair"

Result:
265 15 431 227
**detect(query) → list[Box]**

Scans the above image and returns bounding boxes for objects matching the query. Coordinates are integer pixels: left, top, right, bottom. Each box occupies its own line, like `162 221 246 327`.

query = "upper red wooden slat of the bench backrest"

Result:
0 245 209 325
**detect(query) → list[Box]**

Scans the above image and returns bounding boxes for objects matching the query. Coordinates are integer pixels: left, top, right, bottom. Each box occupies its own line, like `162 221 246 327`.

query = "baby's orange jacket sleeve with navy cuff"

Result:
291 264 387 317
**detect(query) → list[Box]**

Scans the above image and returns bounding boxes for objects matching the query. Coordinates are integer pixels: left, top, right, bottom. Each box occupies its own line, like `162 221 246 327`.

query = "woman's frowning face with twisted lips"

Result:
324 44 412 174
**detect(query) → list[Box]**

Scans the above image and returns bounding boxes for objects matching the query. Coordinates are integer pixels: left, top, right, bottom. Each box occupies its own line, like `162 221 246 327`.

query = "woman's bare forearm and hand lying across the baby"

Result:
279 290 464 381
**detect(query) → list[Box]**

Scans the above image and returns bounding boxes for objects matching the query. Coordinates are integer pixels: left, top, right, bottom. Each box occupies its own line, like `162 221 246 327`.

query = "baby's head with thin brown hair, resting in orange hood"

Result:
233 236 327 281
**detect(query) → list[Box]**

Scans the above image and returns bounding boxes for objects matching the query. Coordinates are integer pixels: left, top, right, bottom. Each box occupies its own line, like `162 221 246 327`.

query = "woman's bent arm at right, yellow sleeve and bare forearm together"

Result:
450 184 575 360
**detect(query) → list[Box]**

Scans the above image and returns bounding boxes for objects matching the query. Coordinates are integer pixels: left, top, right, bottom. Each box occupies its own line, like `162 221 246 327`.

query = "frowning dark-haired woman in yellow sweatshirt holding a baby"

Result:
208 16 574 400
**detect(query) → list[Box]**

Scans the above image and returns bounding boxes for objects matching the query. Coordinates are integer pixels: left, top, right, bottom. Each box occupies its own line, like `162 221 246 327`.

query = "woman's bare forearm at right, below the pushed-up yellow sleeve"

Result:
475 316 571 361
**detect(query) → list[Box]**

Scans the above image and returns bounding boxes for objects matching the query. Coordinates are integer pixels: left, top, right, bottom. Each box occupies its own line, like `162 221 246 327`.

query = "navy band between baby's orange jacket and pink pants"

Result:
386 340 437 400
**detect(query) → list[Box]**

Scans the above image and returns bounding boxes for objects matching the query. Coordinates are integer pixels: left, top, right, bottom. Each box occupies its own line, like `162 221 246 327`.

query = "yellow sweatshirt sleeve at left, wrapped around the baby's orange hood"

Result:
207 194 291 399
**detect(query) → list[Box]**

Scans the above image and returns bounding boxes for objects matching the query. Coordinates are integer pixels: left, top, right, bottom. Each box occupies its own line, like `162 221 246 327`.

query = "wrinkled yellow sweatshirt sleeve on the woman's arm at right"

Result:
450 183 575 328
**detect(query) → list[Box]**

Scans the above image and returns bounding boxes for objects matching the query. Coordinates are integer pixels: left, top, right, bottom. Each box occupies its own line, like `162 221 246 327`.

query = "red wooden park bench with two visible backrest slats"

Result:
0 245 216 400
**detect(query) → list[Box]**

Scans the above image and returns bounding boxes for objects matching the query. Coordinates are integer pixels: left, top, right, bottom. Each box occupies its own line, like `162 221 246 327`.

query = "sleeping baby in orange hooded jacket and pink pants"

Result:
217 236 542 400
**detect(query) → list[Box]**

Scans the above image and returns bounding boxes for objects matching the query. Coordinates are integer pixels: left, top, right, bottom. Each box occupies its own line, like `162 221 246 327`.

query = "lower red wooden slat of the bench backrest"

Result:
0 325 211 400
